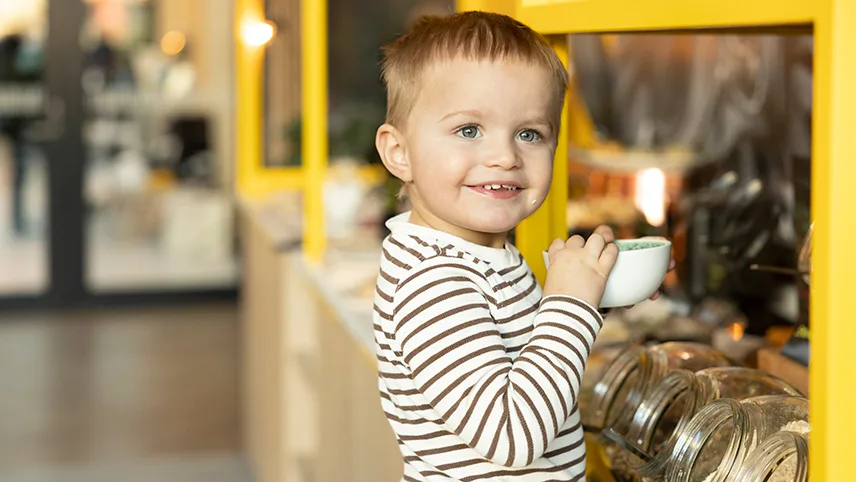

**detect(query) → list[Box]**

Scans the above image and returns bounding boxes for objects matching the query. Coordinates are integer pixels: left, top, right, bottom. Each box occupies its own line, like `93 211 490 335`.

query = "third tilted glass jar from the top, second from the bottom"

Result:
660 395 808 482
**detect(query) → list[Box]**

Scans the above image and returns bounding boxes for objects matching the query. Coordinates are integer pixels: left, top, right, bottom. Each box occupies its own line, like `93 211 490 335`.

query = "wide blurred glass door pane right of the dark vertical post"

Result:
78 0 238 295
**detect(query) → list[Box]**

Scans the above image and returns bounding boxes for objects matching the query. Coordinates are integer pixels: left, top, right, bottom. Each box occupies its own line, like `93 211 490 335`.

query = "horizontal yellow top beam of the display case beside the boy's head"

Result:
517 0 820 34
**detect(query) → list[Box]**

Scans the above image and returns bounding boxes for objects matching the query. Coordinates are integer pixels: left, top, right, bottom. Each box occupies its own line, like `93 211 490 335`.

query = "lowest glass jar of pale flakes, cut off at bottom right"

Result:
734 431 808 482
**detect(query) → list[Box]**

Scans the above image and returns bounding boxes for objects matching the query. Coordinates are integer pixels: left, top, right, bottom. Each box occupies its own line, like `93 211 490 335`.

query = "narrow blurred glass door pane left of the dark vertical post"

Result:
0 0 50 304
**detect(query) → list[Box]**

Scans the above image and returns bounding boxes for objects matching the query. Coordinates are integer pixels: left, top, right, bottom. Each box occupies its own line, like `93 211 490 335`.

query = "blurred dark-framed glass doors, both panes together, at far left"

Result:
0 0 239 310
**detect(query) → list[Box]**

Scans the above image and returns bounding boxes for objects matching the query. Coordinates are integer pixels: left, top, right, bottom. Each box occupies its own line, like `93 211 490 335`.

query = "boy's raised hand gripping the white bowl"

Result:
544 226 618 308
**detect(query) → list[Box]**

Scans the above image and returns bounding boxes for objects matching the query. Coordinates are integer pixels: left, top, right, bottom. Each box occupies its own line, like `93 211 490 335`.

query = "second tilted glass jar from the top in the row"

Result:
627 367 802 456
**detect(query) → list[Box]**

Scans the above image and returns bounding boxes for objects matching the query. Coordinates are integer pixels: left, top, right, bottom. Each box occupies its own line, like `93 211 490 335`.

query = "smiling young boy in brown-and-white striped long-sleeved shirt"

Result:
374 12 660 481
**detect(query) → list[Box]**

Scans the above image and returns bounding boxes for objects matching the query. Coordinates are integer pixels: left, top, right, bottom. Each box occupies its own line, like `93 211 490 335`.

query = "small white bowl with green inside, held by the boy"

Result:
543 237 672 308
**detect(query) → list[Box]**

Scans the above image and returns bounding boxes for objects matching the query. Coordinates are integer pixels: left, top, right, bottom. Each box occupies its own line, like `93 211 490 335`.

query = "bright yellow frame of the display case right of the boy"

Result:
484 0 856 481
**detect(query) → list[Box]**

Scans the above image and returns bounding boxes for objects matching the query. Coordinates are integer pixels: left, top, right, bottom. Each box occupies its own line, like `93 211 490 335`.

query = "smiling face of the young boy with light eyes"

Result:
379 60 557 247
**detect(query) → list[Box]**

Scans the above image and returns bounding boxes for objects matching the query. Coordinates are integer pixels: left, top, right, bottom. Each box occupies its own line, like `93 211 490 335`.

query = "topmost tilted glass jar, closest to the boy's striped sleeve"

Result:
582 342 734 433
